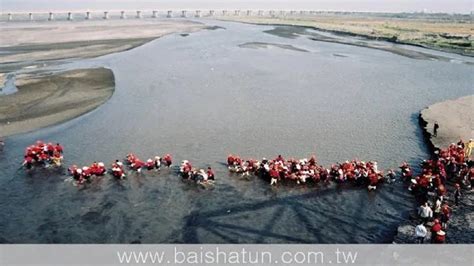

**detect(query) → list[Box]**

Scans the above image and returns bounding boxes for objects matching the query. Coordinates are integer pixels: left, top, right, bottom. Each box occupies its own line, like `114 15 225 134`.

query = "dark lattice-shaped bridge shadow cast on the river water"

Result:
179 183 409 244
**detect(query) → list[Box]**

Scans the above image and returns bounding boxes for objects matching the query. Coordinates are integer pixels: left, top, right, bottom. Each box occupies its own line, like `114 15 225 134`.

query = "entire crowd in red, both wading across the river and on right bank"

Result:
22 140 474 243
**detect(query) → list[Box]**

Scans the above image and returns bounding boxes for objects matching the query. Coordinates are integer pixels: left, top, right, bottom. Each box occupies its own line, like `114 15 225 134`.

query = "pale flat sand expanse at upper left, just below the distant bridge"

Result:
0 20 205 64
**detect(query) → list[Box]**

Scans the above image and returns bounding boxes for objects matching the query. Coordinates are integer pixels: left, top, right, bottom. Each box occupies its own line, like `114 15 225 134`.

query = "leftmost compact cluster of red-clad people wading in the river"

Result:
22 140 64 169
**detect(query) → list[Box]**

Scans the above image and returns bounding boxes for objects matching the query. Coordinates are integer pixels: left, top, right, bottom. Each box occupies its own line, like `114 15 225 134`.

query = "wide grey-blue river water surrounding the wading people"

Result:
0 18 473 243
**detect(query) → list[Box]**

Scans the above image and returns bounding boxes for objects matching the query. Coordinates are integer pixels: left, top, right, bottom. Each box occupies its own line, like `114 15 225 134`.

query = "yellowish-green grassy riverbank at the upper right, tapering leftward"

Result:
219 12 474 56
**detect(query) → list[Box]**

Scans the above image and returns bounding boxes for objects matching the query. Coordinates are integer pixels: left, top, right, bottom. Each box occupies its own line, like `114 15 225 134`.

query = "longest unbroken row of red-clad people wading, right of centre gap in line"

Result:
227 154 386 190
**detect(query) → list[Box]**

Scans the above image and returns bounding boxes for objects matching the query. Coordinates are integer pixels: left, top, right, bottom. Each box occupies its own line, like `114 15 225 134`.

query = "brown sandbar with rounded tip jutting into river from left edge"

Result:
0 68 115 137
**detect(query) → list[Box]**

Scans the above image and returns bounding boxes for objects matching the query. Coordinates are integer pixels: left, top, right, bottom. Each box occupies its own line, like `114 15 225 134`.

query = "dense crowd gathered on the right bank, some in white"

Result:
410 140 474 243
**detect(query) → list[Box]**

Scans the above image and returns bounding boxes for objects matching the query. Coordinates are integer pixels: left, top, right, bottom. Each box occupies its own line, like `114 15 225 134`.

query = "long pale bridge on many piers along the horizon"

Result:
0 9 320 21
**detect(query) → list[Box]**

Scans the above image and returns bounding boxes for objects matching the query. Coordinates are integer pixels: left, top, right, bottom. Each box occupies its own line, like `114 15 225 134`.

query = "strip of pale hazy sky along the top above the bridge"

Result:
0 0 474 13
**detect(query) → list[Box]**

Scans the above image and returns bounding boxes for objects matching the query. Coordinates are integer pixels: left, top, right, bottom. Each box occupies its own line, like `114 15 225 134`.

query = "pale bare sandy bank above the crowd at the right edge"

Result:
420 95 474 148
